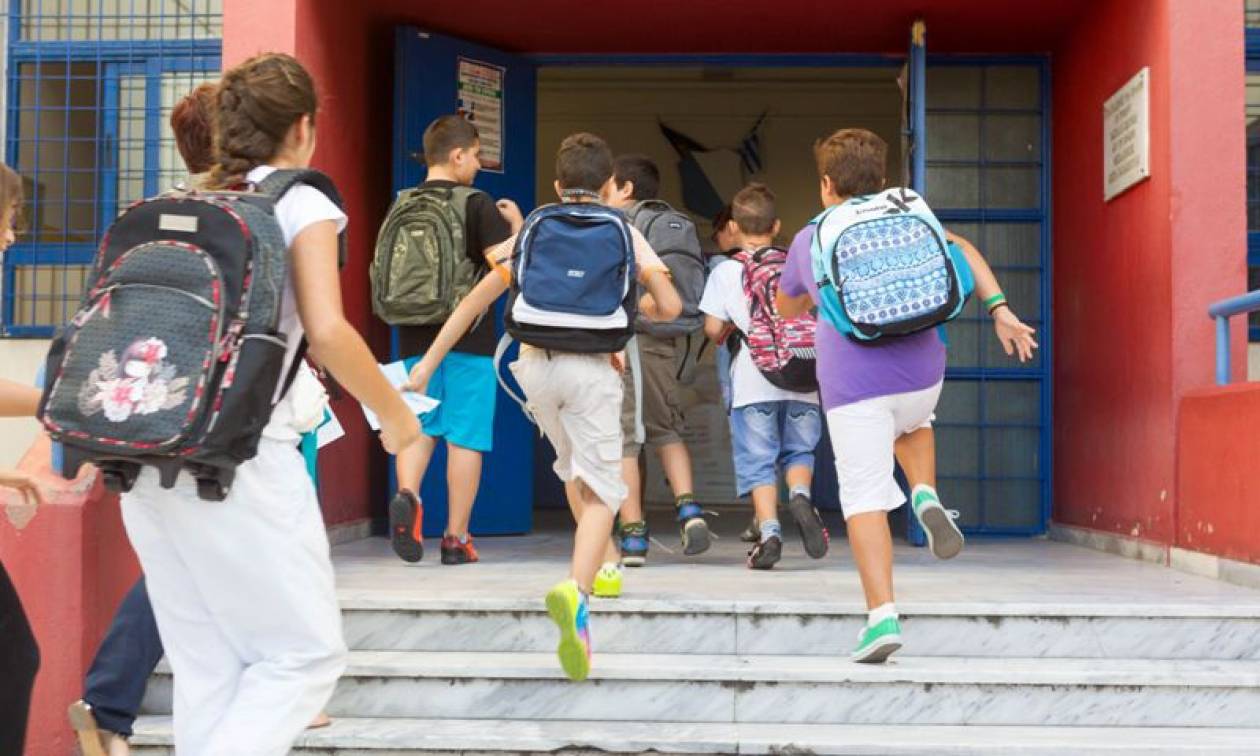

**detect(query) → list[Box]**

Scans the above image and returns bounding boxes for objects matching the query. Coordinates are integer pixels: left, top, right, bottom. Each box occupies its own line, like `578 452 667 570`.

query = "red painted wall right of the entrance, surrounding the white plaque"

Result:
1053 0 1245 544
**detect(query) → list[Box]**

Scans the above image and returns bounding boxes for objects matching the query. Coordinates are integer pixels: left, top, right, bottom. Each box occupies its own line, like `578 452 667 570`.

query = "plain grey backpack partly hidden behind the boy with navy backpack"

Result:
626 199 706 339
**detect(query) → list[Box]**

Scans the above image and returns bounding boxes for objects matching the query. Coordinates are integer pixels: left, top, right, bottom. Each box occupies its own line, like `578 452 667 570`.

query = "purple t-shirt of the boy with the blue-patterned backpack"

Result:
779 226 945 410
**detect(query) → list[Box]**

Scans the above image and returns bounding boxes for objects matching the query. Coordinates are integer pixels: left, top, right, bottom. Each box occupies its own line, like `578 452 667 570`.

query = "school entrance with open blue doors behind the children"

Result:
393 25 1051 541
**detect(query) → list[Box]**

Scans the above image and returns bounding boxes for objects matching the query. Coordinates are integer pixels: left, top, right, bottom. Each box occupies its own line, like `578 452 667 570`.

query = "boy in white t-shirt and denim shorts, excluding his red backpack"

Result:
701 184 828 570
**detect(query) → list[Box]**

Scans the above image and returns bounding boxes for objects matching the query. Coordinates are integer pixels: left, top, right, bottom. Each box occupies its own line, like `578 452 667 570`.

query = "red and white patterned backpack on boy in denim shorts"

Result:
733 247 818 392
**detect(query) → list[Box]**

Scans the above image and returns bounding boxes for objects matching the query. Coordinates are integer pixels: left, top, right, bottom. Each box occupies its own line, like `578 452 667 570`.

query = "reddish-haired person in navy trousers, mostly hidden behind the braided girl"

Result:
69 83 330 756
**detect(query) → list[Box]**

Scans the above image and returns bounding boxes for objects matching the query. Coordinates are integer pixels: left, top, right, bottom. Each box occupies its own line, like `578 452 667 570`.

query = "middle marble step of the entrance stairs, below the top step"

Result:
145 651 1260 727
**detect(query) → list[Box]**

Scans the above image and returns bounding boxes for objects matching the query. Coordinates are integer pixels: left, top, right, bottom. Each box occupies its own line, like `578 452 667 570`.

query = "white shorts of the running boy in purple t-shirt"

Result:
827 382 944 519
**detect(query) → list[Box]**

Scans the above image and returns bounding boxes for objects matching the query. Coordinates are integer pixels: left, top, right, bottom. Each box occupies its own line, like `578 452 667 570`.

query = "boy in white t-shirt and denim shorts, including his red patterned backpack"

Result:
701 184 828 570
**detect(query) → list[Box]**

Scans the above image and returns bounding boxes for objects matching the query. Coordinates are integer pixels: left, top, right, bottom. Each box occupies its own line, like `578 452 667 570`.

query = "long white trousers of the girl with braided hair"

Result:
122 438 347 756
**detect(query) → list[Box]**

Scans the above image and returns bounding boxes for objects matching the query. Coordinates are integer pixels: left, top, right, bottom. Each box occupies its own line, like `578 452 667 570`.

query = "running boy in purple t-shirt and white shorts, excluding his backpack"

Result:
777 129 1037 663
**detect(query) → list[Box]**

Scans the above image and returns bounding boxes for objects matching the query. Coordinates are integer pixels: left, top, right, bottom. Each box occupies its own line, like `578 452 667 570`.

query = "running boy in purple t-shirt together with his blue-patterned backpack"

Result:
779 129 1037 663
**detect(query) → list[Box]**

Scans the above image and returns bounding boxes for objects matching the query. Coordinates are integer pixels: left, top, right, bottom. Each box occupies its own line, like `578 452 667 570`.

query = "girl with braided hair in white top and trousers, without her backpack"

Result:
115 54 420 756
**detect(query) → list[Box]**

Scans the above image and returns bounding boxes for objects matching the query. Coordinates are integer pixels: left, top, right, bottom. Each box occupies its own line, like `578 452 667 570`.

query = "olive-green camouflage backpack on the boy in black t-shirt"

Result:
370 186 484 325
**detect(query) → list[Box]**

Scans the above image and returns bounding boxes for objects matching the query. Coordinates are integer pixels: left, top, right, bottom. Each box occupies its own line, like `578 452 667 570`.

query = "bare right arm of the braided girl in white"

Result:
292 221 420 454
